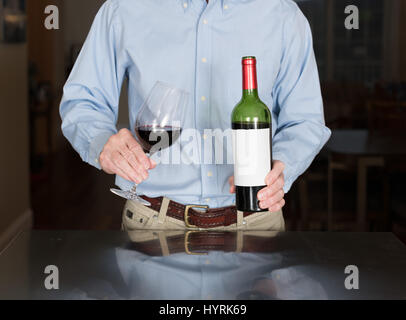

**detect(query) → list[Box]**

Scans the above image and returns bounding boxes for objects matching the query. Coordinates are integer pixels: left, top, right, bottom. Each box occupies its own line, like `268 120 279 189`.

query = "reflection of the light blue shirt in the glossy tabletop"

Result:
63 248 328 300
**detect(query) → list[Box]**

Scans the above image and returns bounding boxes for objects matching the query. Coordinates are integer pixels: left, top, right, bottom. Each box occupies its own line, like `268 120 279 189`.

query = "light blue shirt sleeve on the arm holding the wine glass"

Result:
60 1 126 169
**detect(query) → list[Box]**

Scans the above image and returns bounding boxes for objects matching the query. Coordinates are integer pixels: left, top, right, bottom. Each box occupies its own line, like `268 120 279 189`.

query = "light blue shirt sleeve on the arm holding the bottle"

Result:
273 8 331 192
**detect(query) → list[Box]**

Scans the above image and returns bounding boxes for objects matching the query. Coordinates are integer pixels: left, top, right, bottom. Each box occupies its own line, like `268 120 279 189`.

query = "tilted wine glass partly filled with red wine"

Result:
110 81 189 206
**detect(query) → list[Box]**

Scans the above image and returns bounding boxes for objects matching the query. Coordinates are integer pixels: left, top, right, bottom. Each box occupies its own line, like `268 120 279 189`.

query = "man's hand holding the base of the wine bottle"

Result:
229 160 285 212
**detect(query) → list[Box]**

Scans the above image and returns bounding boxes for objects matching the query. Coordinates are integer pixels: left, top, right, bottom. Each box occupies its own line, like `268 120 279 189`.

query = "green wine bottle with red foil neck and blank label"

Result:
231 57 272 212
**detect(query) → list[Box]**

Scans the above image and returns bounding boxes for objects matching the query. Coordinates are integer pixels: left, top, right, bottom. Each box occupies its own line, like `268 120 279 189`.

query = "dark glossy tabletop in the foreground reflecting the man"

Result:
0 231 406 300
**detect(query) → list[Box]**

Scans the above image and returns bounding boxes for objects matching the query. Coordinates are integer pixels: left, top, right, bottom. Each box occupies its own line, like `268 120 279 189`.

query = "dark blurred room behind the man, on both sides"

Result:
0 0 406 250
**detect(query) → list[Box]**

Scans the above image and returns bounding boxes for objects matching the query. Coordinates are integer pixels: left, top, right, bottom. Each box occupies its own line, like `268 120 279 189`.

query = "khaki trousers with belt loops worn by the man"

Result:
122 198 285 231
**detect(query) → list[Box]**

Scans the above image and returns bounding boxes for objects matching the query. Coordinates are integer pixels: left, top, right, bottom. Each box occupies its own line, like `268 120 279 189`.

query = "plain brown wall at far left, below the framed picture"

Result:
0 44 31 250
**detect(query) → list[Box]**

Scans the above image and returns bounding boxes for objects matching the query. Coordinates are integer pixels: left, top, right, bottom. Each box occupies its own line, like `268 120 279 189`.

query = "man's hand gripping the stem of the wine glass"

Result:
99 129 156 184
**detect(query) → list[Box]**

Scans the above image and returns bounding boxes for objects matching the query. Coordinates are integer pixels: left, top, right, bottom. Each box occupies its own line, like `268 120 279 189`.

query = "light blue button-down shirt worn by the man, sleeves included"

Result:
60 0 330 207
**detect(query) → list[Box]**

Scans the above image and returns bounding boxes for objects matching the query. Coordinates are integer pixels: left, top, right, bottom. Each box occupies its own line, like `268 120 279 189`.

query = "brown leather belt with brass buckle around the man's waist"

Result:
142 196 256 229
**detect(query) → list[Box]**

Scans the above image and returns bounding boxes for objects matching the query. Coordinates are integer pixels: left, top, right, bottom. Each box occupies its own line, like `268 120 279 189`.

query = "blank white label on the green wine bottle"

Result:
233 128 271 187
